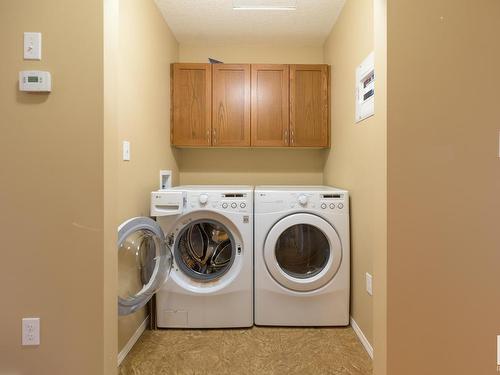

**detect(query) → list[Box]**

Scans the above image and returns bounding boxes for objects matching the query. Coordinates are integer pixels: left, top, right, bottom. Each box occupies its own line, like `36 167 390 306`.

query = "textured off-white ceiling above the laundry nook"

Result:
155 0 346 45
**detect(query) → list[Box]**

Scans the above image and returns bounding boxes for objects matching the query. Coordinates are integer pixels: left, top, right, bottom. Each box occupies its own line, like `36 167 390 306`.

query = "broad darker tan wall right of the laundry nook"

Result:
387 0 500 375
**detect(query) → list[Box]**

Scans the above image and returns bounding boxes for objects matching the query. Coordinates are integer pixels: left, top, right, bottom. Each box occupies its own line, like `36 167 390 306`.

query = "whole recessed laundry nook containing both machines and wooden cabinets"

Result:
109 0 386 374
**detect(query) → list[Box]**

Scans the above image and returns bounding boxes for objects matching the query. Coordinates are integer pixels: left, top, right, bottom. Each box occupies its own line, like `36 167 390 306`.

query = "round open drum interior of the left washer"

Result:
174 220 235 281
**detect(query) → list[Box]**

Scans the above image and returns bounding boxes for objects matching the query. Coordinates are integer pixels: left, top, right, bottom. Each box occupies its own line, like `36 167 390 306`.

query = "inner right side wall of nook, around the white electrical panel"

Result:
325 0 386 350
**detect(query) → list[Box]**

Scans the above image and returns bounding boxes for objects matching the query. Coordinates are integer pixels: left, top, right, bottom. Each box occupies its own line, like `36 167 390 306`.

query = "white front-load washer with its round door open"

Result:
118 186 253 328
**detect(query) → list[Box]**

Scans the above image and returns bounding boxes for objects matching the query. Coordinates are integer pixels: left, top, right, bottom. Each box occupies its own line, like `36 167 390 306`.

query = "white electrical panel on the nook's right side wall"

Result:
356 52 375 122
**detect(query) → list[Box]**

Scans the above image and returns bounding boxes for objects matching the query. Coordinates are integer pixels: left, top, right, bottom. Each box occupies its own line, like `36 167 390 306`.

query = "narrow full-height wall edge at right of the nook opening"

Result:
372 0 387 375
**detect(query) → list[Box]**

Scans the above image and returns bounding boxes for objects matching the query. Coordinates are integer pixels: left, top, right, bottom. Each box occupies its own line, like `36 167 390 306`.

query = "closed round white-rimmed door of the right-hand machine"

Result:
264 213 342 292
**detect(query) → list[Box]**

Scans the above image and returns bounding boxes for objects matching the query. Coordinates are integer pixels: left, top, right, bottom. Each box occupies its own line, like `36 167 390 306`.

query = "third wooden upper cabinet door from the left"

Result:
252 64 290 147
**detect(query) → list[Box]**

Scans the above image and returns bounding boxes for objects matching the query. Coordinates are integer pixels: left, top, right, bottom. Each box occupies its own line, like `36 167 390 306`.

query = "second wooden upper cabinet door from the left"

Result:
212 64 250 147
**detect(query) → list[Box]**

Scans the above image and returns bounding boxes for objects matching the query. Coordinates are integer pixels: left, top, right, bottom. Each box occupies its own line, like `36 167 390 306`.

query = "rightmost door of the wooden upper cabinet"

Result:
290 65 330 147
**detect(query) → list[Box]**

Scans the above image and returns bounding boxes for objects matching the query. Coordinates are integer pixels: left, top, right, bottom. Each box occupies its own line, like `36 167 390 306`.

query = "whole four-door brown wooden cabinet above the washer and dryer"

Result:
171 63 330 147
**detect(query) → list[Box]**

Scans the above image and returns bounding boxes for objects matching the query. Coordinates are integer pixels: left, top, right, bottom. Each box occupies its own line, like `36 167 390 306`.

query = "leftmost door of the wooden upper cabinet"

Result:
171 64 212 146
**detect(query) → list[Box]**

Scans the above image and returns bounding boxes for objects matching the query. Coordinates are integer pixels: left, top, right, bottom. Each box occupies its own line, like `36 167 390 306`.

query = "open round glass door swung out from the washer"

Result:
117 217 172 315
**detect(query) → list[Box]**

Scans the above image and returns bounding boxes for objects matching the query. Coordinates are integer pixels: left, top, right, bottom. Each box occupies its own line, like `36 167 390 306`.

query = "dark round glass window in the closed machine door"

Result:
275 224 330 279
